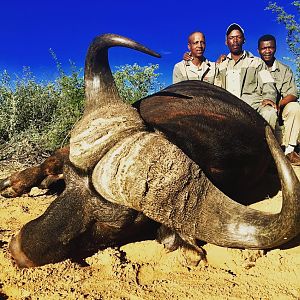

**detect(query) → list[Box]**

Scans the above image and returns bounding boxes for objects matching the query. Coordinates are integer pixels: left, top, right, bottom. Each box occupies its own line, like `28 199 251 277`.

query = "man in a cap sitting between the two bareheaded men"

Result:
215 23 277 129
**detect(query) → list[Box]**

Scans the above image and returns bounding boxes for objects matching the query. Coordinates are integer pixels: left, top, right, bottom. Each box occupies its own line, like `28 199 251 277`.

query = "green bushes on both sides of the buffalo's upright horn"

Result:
0 55 161 162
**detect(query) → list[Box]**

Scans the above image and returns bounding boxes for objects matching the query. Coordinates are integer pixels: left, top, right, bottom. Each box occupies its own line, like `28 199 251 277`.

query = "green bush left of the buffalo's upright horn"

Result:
0 63 84 159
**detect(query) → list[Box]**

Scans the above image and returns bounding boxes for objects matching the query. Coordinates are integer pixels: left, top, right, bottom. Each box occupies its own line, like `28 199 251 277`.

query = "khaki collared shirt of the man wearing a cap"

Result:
215 51 277 109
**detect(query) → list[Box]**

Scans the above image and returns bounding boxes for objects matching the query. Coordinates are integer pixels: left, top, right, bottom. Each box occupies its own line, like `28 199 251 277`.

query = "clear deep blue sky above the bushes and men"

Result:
0 0 296 85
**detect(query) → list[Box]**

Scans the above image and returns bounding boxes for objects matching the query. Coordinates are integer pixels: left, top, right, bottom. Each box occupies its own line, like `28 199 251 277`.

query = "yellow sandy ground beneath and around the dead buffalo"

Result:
0 167 300 300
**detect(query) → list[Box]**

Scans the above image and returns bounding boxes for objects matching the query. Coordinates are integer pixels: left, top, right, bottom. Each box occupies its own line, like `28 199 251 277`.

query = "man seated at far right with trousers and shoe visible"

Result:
258 34 300 166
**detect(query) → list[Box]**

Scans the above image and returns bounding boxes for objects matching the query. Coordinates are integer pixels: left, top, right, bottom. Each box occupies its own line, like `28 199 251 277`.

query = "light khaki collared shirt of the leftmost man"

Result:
173 59 216 84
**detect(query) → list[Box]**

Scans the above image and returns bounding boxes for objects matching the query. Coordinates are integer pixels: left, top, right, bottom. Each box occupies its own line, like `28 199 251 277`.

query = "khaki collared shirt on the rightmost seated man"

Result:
269 59 298 101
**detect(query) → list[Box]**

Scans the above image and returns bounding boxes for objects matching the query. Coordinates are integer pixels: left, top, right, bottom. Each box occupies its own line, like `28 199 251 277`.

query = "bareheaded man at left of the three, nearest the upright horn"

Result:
173 31 216 84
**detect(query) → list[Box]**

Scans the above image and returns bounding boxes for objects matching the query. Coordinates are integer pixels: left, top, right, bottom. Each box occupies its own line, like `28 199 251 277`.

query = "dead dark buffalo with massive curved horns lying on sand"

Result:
9 34 300 267
